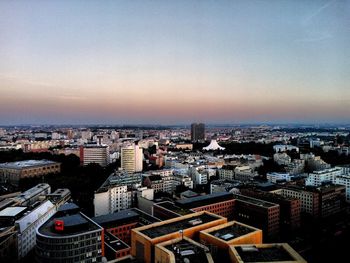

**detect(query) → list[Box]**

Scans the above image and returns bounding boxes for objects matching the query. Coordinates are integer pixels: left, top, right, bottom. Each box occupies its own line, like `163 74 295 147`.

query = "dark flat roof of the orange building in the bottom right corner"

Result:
236 246 293 262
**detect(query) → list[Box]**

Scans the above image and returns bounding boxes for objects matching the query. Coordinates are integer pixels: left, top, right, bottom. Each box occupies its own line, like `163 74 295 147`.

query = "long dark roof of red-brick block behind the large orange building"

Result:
175 192 233 209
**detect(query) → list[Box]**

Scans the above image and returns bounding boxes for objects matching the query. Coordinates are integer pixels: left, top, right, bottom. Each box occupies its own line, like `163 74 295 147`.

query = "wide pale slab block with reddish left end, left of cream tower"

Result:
80 144 109 167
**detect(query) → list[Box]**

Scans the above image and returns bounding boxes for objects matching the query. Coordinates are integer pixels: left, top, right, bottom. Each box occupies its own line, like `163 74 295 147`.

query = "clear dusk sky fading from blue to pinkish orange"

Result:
0 0 350 125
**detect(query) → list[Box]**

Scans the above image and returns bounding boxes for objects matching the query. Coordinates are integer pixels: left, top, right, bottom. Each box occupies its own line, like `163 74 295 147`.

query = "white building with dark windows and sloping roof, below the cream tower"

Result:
94 173 142 216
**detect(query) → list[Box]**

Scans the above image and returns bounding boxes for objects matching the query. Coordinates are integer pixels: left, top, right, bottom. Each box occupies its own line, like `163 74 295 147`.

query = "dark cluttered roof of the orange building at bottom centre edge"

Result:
165 239 208 263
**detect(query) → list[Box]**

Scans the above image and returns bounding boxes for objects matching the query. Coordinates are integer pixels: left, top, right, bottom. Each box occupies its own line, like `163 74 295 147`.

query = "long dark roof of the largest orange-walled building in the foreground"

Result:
140 214 218 238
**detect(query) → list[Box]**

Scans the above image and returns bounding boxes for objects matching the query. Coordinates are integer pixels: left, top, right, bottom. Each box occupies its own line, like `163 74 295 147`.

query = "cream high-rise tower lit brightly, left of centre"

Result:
121 144 143 173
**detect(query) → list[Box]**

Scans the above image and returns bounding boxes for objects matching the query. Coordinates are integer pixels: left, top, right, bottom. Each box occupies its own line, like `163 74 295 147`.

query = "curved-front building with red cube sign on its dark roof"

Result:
36 203 104 263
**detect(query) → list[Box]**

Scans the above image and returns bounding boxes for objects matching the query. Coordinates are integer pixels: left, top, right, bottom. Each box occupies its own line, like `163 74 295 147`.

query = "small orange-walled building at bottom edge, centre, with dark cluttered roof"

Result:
154 237 214 263
